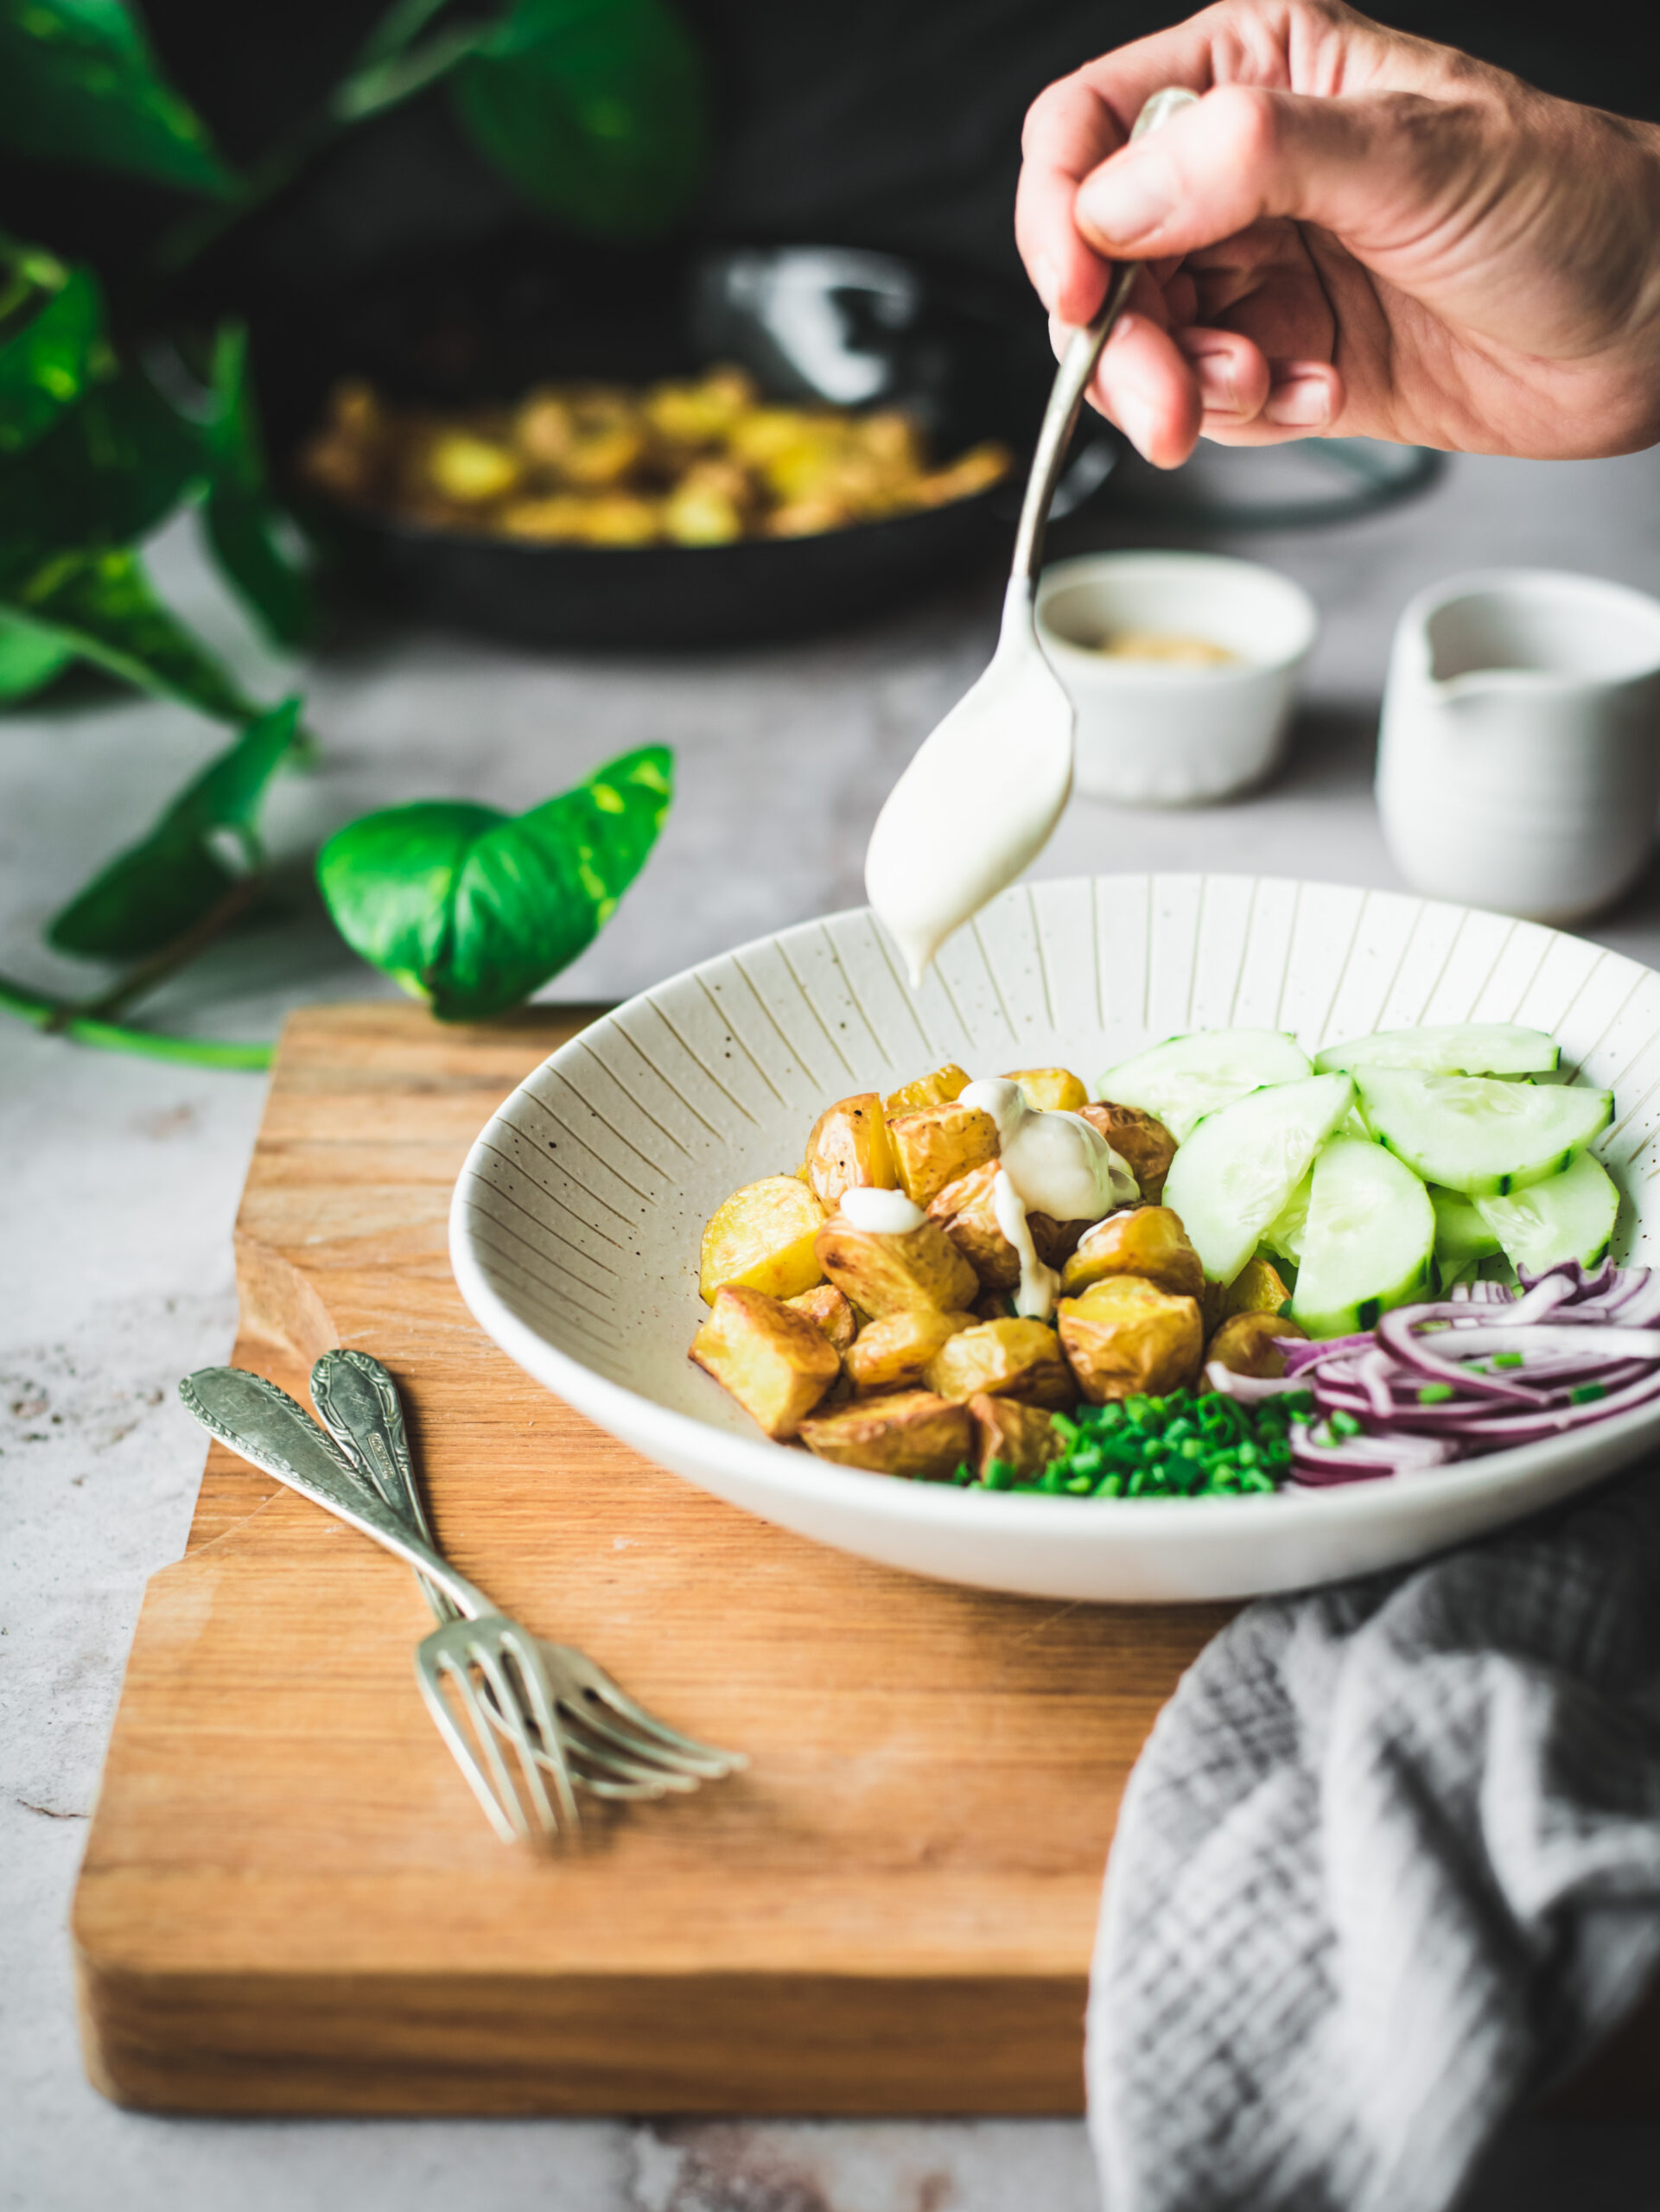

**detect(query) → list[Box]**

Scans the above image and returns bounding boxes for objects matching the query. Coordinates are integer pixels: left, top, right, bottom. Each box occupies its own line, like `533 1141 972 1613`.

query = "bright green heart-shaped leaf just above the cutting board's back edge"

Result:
316 746 673 1022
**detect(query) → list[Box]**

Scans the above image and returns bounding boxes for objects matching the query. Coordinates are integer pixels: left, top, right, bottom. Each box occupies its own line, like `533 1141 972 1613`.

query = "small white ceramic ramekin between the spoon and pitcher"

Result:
1038 553 1320 807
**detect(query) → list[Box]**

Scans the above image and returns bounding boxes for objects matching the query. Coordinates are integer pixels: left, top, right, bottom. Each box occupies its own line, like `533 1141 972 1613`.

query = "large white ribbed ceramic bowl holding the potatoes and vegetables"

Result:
449 876 1660 1601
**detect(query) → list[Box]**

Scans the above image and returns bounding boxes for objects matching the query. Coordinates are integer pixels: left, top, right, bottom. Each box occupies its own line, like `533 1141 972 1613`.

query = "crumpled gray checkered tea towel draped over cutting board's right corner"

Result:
1087 1469 1660 2212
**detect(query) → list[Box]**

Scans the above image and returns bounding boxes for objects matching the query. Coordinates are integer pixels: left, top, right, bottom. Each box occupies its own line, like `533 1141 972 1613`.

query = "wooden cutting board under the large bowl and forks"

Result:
73 1004 1660 2113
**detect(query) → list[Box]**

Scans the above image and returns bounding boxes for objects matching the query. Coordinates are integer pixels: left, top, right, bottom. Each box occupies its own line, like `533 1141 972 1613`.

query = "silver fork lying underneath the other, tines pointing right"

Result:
312 1351 748 1798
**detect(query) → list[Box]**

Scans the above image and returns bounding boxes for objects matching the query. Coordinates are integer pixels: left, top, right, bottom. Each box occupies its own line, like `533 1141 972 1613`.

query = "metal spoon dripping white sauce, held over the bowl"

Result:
865 86 1198 984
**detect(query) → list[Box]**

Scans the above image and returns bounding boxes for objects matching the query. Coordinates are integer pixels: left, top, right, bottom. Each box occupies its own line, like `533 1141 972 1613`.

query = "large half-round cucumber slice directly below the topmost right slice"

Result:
1355 1068 1613 1199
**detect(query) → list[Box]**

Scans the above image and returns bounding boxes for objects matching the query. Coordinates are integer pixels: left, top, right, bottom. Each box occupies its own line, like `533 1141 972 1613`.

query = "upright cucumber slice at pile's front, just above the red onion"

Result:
1290 1137 1434 1336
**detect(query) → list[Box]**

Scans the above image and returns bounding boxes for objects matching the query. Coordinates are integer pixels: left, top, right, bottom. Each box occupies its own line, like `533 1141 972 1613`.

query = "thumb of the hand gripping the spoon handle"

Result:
1073 84 1474 261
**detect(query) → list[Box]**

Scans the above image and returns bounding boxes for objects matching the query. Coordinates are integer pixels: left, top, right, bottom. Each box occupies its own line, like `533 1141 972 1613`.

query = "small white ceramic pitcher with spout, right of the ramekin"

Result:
1377 569 1660 923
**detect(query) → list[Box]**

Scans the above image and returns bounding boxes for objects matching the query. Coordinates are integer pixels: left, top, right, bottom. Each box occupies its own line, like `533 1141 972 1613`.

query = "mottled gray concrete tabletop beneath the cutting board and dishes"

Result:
0 440 1660 2212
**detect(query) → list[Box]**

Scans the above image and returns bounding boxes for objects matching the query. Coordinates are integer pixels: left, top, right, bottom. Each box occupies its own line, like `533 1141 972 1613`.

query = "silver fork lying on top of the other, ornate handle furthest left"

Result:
179 1367 580 1842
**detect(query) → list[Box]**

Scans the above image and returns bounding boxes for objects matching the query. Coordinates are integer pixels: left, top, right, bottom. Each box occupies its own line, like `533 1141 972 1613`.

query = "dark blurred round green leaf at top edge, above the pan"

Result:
452 0 709 238
